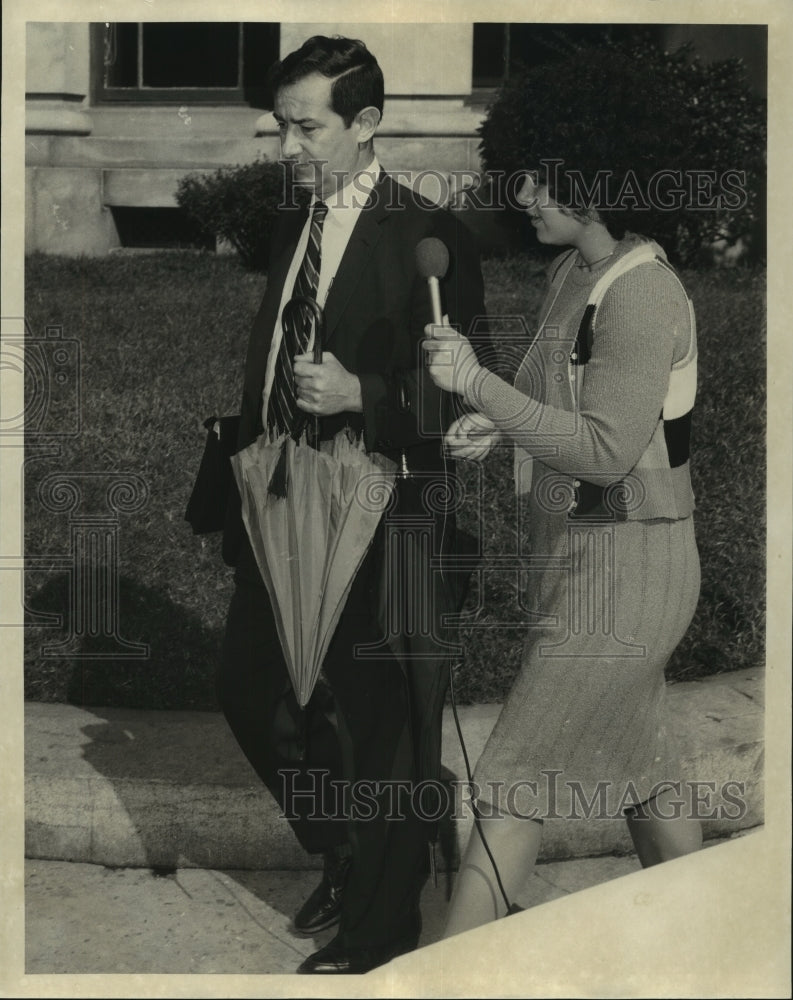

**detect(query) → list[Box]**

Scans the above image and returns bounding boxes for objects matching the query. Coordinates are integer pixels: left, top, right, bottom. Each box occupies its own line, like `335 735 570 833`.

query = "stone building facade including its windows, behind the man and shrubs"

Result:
25 22 762 255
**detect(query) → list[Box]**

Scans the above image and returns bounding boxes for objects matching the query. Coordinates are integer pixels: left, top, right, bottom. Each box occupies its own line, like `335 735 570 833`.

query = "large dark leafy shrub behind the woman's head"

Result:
479 38 766 265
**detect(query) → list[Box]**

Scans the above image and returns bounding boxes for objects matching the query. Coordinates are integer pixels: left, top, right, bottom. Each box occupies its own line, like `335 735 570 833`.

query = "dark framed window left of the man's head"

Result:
94 21 280 107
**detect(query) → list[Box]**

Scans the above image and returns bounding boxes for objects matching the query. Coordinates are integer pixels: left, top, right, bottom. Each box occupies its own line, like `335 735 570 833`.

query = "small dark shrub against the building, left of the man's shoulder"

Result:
176 157 300 271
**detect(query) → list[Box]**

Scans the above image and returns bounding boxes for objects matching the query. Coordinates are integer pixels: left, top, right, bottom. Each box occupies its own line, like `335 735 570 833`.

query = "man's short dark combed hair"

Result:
270 35 385 128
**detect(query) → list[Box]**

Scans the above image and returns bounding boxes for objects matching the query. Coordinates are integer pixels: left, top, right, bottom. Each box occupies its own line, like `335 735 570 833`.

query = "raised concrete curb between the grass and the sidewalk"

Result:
25 669 765 870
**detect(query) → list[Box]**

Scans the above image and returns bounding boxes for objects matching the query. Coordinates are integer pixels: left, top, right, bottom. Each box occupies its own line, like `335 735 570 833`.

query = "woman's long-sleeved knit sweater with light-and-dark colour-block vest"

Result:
468 237 697 520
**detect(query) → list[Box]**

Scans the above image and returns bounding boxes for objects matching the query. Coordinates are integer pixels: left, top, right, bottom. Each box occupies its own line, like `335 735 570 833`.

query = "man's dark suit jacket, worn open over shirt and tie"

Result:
223 173 485 566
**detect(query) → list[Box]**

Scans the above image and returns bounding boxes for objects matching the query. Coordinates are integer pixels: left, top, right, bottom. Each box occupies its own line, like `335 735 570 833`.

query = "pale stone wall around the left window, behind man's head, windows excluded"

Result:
25 23 484 255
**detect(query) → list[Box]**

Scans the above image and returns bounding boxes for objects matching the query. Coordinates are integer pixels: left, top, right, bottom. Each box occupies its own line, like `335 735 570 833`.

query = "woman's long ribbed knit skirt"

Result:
474 492 700 819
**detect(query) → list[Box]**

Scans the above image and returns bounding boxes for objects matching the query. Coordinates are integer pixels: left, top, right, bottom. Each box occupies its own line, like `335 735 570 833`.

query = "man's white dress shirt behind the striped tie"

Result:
262 157 380 427
